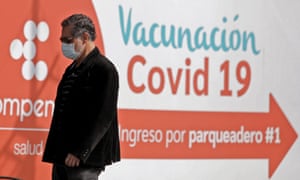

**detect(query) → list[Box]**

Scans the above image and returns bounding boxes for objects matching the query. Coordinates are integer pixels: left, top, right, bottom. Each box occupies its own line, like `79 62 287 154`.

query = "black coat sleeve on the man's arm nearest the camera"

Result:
74 61 119 162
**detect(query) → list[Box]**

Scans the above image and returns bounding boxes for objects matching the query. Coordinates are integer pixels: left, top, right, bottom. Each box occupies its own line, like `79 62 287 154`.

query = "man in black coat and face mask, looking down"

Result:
43 14 120 180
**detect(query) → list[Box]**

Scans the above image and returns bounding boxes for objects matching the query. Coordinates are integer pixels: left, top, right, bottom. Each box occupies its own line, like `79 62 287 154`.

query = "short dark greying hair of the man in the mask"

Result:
61 14 96 41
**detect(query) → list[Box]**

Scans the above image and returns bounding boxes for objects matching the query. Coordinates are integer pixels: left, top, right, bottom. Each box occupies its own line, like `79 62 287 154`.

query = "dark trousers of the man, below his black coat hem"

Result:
52 164 100 180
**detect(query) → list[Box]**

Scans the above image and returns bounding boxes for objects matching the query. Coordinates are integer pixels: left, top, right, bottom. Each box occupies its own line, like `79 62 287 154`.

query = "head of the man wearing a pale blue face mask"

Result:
60 14 96 62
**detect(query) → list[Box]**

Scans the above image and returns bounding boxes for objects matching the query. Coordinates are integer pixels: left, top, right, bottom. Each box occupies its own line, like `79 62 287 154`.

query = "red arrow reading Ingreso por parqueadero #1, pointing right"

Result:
119 95 297 177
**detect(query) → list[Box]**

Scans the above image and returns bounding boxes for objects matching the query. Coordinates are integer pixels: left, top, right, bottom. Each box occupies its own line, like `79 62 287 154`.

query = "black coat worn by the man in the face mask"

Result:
42 48 120 169
